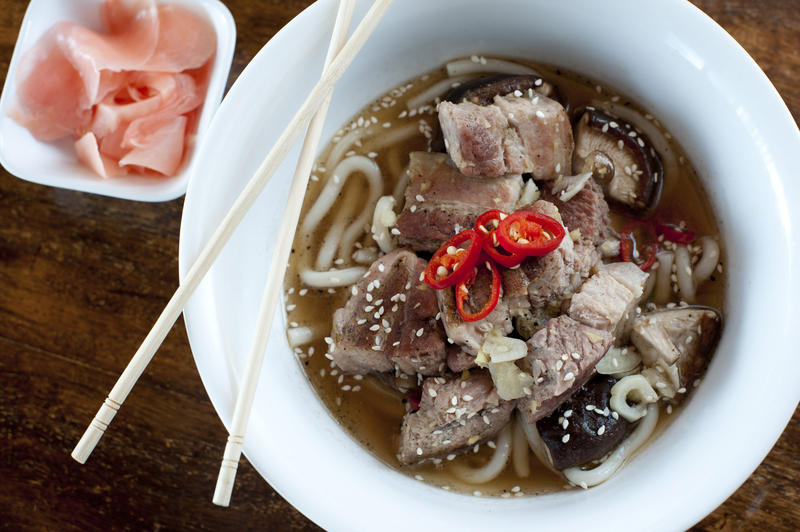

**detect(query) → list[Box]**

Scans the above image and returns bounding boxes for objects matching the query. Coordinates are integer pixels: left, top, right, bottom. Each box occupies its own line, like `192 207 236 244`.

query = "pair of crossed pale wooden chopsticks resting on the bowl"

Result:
72 0 393 506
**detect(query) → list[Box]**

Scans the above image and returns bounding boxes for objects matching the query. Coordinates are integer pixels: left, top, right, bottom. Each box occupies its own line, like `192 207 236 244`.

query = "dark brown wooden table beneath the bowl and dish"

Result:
0 0 800 531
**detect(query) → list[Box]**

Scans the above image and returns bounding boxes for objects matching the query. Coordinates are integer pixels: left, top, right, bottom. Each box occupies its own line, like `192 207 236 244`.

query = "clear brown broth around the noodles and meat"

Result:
285 59 725 497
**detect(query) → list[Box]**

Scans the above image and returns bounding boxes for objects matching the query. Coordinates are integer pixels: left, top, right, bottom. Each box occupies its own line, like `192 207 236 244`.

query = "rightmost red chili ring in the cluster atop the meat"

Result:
496 211 566 257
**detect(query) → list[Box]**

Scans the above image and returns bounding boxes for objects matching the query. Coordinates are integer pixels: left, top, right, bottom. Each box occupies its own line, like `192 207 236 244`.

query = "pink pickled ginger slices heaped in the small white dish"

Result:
9 0 216 178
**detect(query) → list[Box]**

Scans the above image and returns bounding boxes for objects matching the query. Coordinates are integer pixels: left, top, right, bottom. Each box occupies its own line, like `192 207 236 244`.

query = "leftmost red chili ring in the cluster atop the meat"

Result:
425 229 483 290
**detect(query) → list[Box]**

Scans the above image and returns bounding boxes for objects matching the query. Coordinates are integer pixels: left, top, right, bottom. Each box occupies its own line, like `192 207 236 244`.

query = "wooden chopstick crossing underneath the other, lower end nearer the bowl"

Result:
213 0 355 506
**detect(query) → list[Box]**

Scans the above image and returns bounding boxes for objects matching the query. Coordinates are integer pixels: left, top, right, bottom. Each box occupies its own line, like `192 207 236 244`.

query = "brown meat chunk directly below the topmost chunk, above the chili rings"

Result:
396 152 522 252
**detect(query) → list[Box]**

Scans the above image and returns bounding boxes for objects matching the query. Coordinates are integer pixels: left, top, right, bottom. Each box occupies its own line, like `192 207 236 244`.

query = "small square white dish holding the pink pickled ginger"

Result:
0 0 236 201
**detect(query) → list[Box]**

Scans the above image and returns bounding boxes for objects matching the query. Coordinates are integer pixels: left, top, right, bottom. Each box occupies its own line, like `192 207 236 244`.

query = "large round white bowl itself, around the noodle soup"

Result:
180 0 800 532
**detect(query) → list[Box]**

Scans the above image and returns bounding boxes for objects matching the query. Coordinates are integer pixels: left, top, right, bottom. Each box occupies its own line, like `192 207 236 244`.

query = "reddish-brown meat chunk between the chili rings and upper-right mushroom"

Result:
543 179 611 245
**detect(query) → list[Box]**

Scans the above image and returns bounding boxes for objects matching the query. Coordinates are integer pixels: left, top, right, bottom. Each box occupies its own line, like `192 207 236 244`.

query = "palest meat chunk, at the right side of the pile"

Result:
568 262 647 341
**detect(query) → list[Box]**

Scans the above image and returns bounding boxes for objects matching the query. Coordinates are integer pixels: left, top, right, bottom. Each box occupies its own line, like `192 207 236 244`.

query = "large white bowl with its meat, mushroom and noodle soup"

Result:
180 0 800 530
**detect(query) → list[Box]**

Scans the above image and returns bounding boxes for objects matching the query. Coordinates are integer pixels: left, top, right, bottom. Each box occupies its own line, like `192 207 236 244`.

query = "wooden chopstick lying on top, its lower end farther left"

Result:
72 0 393 463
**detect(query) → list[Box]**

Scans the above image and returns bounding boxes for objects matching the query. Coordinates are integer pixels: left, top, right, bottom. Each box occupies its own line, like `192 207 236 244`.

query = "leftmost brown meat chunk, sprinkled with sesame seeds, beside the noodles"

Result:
330 249 446 375
